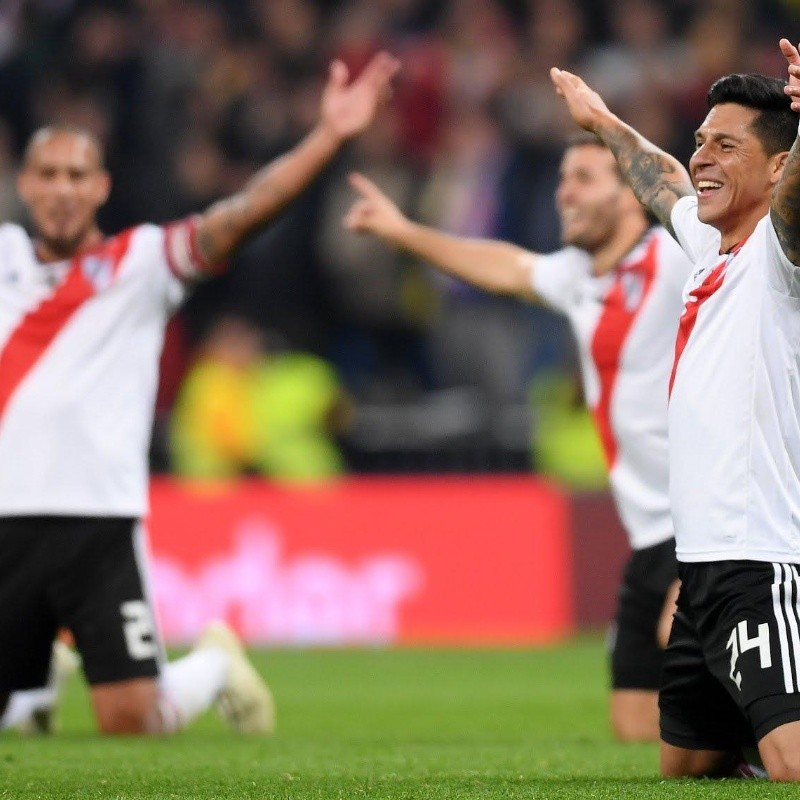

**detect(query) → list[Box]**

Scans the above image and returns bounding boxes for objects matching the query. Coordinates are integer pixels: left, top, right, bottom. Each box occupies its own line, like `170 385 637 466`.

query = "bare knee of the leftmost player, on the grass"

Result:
92 678 162 735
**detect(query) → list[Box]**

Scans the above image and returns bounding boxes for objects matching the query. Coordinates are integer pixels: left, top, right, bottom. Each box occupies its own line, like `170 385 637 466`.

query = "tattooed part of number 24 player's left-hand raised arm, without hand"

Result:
598 124 694 237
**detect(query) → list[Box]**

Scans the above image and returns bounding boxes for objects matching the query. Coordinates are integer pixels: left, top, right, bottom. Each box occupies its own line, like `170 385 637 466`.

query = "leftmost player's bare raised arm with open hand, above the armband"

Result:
191 53 399 263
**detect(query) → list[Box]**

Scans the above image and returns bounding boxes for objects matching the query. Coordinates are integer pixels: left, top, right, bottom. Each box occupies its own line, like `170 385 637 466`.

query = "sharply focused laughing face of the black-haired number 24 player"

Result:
689 103 776 235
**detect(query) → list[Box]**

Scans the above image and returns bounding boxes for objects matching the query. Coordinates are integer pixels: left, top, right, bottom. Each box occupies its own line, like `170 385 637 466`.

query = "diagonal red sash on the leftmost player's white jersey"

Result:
0 229 133 420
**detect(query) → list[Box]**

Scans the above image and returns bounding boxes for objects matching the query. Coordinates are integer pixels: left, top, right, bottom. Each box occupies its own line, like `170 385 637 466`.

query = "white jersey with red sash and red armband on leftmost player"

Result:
0 220 209 517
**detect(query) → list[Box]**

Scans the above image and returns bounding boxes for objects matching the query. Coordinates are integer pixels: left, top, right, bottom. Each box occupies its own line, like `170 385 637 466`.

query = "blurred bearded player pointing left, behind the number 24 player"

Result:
345 135 691 741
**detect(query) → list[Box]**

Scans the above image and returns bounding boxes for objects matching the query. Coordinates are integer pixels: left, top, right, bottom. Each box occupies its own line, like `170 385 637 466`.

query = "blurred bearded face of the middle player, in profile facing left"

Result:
556 144 631 253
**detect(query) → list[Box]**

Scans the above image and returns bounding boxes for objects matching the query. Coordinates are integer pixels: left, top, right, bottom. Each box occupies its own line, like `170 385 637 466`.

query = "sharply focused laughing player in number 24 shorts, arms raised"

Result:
551 39 800 781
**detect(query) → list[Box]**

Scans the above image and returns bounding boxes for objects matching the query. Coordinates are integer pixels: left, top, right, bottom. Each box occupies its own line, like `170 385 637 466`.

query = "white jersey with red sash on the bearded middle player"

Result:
532 228 691 550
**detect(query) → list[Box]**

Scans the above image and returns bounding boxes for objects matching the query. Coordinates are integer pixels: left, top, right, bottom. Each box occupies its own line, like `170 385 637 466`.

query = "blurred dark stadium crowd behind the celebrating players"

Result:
0 0 800 483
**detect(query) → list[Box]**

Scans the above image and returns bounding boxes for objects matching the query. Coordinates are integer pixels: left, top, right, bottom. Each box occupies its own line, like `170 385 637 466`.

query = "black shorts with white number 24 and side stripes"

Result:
659 561 800 750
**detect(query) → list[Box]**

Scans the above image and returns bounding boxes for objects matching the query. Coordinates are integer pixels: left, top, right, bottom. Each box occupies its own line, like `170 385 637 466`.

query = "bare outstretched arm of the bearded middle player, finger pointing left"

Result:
344 173 536 300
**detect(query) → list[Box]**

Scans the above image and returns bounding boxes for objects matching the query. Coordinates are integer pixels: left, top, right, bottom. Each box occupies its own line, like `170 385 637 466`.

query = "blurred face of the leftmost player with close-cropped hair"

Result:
18 131 110 257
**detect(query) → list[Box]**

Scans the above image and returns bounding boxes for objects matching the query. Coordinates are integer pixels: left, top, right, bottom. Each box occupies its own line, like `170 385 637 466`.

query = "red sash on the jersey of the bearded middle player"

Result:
591 236 658 469
